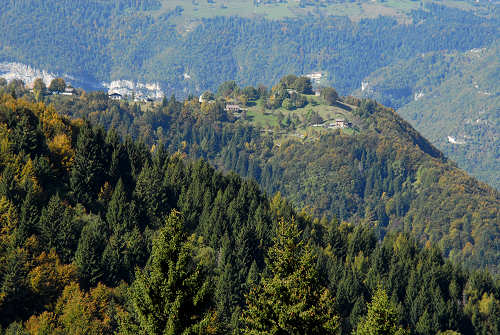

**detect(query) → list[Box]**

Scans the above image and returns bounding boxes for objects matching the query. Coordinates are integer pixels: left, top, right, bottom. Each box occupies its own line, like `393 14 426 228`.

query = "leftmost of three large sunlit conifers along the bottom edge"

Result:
132 211 215 335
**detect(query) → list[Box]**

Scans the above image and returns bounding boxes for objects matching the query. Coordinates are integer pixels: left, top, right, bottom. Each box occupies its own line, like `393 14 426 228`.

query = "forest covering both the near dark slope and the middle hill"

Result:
0 76 500 335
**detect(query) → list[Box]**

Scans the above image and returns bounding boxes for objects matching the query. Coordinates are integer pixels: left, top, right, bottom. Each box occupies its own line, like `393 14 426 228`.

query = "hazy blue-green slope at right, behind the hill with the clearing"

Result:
355 41 500 189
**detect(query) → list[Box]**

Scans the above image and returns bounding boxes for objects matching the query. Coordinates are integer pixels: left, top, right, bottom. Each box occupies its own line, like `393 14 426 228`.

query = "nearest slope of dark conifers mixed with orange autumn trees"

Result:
0 92 500 335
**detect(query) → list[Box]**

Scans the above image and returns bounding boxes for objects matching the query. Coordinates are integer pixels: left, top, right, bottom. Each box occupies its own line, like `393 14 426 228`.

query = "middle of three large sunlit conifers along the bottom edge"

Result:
242 220 338 335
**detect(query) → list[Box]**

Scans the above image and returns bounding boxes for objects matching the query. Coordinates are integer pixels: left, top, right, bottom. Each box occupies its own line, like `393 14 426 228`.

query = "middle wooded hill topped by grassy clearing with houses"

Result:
13 75 500 272
